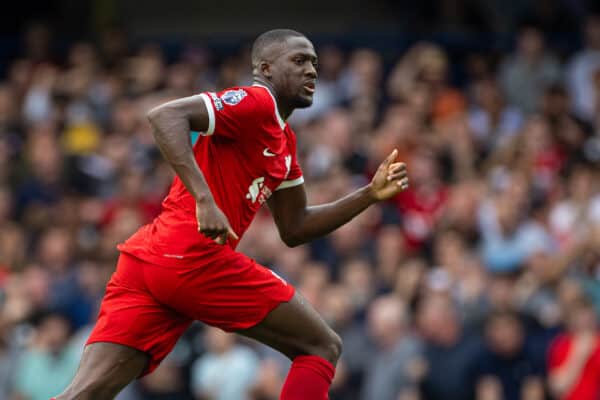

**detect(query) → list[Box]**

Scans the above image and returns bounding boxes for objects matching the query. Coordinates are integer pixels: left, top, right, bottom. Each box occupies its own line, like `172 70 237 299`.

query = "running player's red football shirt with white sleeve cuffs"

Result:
118 85 304 266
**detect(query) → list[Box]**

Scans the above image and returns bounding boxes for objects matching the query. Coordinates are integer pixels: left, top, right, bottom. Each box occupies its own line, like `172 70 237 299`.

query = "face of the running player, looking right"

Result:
273 37 317 108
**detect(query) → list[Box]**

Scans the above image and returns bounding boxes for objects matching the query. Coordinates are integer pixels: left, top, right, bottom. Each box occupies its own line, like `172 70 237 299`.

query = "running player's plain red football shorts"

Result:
87 247 294 375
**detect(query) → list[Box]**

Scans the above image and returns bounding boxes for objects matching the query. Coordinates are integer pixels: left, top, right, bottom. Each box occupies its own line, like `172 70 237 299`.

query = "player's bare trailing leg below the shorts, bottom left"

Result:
56 342 150 400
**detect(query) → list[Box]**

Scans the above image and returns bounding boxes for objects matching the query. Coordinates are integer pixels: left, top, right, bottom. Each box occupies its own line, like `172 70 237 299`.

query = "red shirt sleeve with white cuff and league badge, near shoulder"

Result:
200 88 271 140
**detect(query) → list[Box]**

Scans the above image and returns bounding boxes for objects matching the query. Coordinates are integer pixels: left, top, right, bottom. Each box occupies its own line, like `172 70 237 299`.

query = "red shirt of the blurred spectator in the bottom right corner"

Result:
548 334 600 400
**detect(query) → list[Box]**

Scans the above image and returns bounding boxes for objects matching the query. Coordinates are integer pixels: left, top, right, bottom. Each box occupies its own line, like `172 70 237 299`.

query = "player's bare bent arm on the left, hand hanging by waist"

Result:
148 95 237 244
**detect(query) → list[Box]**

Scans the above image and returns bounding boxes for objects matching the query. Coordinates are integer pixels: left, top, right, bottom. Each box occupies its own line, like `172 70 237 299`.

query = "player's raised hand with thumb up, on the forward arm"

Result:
370 149 408 201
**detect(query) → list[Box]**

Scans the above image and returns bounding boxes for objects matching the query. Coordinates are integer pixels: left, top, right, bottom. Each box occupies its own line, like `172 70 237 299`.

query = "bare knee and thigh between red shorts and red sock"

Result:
238 292 342 364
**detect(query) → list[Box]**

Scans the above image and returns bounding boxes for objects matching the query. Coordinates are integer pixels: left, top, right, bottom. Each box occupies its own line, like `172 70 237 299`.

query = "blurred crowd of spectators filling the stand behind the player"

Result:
0 7 600 400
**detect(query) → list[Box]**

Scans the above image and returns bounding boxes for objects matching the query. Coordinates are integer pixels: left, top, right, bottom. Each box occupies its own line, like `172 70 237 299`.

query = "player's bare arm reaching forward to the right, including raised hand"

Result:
268 150 408 247
